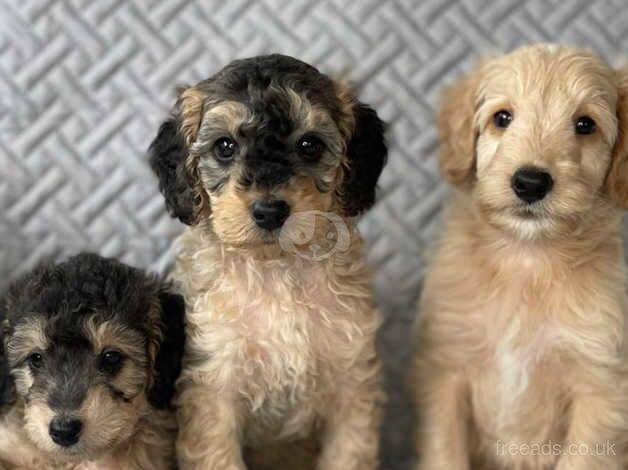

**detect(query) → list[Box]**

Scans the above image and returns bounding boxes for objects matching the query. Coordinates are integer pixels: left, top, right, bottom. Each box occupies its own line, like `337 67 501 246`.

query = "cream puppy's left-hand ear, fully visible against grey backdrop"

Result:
436 69 480 185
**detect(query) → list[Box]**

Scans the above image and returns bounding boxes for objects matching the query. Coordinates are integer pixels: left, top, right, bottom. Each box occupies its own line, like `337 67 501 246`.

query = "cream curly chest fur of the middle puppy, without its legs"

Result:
175 229 379 442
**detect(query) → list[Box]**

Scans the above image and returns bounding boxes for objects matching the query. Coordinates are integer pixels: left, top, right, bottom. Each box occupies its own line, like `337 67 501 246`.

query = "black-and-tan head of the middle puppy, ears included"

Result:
149 55 387 245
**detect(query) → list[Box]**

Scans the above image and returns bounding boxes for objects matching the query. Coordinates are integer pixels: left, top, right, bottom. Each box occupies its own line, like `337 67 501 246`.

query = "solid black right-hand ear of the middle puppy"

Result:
340 102 388 217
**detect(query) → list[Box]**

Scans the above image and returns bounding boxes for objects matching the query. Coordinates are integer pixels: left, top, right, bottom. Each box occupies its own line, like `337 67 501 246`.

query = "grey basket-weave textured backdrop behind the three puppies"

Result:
0 0 628 469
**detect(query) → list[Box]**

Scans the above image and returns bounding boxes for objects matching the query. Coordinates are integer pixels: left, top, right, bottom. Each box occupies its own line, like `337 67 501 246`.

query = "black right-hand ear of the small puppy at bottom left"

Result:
148 292 185 409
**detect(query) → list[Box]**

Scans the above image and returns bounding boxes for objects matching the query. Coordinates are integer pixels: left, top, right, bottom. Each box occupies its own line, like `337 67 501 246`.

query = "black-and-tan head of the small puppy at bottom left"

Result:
3 254 184 459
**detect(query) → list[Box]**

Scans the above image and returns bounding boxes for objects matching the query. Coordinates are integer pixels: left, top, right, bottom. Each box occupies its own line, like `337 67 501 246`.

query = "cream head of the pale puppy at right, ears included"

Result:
438 45 628 238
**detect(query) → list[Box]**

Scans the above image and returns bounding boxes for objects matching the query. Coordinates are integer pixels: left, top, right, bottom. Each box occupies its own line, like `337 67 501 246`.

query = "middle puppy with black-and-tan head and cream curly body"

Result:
149 55 387 470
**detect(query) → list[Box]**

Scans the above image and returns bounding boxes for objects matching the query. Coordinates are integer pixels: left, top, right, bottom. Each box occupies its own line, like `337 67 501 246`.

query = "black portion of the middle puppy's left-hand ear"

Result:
148 117 195 225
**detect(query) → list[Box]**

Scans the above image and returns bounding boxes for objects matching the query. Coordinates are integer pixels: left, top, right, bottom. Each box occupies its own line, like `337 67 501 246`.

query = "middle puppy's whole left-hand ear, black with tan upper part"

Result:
148 87 209 225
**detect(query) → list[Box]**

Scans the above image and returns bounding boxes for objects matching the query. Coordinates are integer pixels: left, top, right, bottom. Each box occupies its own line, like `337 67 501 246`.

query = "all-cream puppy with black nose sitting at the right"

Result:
414 45 628 470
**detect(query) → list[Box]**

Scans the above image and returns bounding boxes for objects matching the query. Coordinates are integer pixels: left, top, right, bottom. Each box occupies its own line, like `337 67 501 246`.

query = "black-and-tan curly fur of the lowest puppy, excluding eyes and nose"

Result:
0 254 184 470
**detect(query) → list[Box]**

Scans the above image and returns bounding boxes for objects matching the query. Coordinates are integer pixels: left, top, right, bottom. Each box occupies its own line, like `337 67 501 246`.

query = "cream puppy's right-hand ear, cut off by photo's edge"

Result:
606 69 628 209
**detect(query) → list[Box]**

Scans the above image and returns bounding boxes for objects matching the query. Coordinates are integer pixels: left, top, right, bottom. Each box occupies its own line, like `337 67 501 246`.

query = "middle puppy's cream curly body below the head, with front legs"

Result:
174 229 382 469
